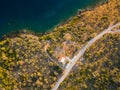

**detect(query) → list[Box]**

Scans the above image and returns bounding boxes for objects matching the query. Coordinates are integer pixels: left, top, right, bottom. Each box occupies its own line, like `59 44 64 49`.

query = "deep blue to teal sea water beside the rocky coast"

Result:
0 0 105 37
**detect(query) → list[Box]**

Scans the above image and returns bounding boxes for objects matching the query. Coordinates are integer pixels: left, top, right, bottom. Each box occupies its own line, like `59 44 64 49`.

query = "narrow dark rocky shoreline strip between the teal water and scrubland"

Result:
0 0 109 41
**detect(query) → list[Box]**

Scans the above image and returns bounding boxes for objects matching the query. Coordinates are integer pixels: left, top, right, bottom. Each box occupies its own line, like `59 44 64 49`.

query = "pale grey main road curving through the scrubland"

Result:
52 22 120 90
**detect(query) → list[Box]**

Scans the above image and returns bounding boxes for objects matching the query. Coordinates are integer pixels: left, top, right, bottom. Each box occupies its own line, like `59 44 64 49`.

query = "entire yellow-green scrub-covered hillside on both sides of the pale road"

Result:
0 0 120 90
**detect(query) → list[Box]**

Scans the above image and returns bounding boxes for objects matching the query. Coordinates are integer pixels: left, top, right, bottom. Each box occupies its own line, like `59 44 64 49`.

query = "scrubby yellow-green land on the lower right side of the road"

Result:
59 33 120 90
